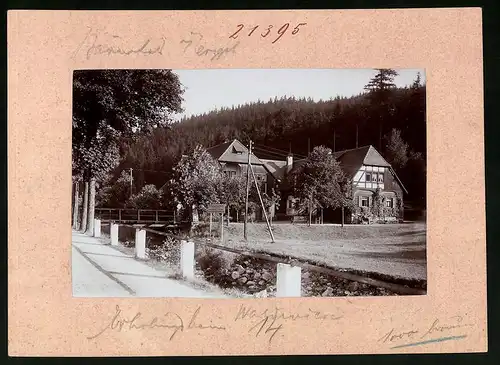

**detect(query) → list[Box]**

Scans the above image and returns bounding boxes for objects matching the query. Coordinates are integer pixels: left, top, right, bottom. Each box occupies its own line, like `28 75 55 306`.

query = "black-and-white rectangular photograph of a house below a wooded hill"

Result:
72 69 427 298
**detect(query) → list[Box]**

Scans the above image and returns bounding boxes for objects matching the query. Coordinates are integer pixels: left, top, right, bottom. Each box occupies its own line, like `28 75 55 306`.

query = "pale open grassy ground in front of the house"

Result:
224 223 427 280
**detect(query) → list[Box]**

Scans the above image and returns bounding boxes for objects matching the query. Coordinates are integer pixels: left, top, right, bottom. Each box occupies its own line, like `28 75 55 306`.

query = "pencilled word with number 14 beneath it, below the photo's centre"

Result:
234 305 343 343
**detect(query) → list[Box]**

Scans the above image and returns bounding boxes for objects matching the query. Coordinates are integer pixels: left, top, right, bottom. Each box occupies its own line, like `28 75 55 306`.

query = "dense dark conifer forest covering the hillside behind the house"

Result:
109 71 426 206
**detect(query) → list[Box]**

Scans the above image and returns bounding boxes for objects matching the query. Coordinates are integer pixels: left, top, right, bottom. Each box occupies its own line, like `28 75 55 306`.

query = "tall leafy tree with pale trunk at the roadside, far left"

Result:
72 70 183 232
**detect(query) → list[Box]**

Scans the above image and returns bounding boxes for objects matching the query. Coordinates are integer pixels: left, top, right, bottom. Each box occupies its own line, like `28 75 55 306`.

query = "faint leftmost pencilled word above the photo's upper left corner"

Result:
73 27 166 60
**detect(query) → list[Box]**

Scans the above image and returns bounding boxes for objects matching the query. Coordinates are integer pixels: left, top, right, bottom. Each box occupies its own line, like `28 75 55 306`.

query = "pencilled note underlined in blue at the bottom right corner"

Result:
378 316 473 348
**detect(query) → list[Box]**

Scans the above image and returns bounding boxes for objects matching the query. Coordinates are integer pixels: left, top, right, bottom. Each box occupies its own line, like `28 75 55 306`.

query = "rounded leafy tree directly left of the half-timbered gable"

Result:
291 146 350 222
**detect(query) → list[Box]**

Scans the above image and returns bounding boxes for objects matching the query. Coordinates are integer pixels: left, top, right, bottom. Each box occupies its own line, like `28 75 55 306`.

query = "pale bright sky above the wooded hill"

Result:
173 69 425 116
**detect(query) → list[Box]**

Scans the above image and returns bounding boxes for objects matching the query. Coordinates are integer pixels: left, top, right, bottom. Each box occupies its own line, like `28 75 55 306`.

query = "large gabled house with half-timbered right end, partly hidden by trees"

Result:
207 139 407 223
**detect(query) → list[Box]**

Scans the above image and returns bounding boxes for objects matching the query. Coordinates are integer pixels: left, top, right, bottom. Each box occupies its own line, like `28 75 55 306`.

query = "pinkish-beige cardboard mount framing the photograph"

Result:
8 8 487 356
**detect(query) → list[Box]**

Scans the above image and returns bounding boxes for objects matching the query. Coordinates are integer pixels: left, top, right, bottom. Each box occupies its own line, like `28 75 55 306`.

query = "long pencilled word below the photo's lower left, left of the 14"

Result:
87 305 226 341
